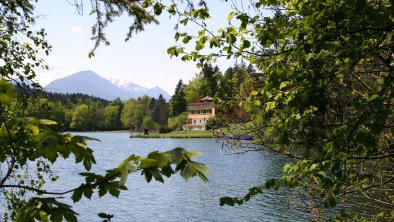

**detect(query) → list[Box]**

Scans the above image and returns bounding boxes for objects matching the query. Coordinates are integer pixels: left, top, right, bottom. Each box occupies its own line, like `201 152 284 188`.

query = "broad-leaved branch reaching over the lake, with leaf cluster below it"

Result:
13 144 208 221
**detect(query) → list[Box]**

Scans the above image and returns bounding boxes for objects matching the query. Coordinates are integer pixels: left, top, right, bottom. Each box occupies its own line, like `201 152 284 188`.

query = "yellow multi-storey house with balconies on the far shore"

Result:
184 96 216 129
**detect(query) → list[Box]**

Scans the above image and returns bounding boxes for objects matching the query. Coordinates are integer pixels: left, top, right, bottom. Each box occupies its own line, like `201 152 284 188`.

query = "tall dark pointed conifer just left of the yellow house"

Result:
170 79 187 117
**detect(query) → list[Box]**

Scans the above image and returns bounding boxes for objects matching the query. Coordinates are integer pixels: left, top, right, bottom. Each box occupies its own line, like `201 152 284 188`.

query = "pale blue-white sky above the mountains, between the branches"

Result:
35 0 233 94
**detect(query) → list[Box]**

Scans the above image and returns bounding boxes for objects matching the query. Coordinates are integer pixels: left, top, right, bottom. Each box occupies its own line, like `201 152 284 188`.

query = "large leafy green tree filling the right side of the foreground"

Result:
168 0 394 221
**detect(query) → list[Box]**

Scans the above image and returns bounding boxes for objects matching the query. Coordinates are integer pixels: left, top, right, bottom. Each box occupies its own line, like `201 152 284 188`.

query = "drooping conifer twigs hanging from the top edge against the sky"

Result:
68 0 209 57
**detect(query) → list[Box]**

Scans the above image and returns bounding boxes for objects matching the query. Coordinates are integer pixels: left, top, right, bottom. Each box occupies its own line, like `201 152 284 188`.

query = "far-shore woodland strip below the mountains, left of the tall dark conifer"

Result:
13 90 169 131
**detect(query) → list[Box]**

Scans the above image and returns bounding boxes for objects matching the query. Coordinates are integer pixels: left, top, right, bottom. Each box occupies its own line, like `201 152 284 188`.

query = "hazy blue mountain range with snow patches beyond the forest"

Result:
44 70 171 101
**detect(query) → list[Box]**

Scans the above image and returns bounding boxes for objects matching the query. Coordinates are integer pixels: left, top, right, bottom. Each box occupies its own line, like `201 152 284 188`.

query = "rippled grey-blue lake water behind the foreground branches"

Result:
48 132 306 222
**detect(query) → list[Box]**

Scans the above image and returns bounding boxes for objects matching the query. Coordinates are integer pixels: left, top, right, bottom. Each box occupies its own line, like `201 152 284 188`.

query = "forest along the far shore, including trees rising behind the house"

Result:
23 63 262 132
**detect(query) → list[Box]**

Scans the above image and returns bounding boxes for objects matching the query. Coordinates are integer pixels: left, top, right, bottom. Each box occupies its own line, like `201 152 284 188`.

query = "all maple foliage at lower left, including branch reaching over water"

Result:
0 81 208 221
